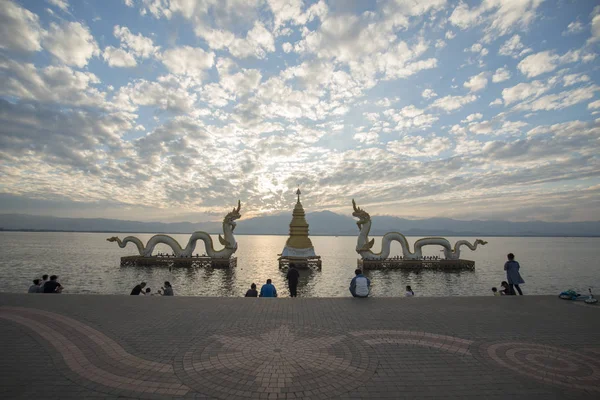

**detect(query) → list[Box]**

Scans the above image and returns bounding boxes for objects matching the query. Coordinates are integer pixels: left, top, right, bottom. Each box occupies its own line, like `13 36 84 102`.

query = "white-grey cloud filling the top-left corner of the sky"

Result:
0 0 44 52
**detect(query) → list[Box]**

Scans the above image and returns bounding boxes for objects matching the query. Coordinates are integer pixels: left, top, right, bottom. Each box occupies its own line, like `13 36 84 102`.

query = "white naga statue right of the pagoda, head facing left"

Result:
352 199 487 260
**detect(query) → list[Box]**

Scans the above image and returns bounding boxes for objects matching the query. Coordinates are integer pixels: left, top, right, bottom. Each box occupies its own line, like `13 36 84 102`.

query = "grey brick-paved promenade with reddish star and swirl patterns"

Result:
0 294 600 400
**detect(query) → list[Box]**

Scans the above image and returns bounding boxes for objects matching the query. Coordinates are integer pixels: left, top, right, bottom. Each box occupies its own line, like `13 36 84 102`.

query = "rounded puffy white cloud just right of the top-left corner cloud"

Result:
43 22 100 68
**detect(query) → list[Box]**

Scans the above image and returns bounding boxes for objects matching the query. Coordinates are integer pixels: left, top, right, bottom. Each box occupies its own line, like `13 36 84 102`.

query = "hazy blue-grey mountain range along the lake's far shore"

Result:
0 211 600 236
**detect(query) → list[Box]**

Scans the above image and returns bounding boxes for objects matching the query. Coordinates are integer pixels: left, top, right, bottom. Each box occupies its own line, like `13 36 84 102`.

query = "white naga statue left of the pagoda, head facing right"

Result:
106 200 241 259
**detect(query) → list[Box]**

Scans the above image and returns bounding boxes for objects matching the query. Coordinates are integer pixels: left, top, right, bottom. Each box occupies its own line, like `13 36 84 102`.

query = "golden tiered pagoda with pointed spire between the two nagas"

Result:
279 188 321 267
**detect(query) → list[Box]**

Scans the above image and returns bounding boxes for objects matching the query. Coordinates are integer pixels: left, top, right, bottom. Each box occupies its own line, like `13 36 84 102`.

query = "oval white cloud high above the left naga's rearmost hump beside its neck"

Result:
161 46 215 80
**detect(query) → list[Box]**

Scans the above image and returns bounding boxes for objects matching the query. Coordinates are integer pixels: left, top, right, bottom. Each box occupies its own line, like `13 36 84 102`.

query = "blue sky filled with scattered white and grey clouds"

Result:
0 0 600 222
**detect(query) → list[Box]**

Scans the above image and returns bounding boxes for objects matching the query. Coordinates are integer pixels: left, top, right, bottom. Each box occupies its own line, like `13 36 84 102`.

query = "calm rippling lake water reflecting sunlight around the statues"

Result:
0 232 600 297
